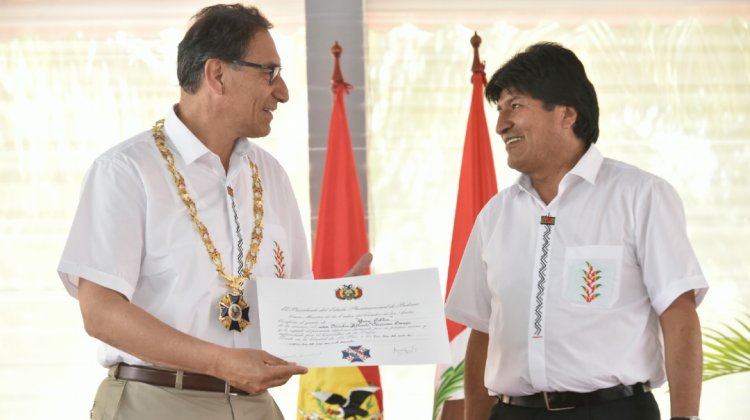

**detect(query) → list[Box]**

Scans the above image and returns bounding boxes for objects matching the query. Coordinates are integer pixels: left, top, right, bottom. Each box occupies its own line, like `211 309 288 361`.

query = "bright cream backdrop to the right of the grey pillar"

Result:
367 15 750 418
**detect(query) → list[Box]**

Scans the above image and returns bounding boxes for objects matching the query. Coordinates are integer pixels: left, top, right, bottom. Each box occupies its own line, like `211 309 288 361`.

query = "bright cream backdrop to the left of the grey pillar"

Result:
0 0 310 419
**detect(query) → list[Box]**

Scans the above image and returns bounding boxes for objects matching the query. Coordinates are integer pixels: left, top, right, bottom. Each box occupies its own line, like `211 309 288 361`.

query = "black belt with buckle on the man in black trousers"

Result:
497 382 651 411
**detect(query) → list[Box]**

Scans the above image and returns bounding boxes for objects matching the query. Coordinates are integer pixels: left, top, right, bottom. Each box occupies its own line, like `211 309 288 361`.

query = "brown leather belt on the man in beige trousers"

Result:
115 363 250 395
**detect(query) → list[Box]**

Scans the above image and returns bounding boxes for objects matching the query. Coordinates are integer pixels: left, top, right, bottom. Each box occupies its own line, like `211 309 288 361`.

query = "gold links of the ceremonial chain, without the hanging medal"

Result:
152 119 263 294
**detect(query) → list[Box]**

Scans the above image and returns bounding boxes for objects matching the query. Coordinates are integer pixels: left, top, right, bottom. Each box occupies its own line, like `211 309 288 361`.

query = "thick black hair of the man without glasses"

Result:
484 42 599 146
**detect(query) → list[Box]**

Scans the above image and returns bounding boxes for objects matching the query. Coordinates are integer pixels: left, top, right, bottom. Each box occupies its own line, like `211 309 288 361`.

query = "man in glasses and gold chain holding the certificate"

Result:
58 5 371 420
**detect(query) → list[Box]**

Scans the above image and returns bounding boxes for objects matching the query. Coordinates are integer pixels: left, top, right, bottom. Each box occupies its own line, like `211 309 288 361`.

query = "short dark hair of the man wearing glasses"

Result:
177 4 273 93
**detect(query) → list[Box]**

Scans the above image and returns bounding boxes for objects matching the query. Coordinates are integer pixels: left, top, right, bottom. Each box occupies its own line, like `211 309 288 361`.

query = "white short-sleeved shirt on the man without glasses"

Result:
446 145 708 396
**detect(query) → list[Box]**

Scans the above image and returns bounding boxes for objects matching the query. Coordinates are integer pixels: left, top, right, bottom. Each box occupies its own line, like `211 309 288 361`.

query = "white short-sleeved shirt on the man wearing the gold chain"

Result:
58 105 312 366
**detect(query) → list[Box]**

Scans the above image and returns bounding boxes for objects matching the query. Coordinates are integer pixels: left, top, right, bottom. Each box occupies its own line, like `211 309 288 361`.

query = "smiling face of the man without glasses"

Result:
495 89 568 174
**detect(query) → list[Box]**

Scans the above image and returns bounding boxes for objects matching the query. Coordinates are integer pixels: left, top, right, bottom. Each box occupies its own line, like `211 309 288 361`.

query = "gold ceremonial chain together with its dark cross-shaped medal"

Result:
152 119 263 332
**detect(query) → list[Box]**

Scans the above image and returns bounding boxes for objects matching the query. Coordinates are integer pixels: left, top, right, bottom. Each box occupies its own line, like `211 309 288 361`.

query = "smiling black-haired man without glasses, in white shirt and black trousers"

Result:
446 43 708 420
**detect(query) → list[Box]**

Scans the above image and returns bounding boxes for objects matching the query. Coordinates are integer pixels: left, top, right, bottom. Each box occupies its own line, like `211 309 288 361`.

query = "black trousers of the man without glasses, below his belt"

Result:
489 392 661 420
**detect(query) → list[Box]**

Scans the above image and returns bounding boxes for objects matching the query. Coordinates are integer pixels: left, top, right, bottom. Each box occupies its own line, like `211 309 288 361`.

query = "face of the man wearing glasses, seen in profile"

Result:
224 30 289 138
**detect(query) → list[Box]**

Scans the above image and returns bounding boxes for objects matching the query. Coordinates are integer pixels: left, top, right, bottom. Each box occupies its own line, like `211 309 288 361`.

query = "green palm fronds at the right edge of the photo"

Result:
703 313 750 381
